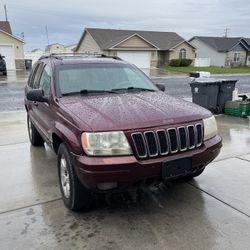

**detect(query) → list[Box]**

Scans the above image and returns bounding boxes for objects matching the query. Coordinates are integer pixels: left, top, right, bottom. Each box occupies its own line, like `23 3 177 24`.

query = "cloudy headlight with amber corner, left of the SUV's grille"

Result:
82 131 132 156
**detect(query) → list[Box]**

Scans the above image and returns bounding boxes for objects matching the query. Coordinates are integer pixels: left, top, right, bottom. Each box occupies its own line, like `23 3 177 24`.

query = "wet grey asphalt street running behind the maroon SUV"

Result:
0 72 250 112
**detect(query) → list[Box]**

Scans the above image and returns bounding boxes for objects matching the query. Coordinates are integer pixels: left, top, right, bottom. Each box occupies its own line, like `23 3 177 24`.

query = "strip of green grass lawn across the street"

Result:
162 66 250 74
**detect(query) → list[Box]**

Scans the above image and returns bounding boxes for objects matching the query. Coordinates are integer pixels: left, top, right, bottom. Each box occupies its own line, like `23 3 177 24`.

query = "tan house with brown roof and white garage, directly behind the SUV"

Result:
75 28 195 68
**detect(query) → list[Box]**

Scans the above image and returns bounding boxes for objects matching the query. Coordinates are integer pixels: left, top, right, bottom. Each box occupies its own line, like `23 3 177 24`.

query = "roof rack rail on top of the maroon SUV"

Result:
39 53 122 60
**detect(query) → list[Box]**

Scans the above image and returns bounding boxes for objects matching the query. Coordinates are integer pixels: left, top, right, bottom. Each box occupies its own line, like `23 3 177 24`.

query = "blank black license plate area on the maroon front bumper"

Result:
162 157 192 178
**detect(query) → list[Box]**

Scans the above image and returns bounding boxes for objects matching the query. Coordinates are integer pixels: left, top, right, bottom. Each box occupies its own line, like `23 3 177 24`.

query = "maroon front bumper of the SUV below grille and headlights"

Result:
72 136 222 191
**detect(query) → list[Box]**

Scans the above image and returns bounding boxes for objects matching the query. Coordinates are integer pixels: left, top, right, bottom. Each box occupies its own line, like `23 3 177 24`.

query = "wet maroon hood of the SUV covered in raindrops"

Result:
60 91 211 131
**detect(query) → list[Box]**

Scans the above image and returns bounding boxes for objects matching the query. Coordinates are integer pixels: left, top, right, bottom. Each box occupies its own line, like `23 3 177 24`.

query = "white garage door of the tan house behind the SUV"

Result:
117 51 151 69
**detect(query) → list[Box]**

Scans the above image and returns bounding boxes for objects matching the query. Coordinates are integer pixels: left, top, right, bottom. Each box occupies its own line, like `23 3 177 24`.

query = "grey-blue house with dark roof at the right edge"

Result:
189 36 250 66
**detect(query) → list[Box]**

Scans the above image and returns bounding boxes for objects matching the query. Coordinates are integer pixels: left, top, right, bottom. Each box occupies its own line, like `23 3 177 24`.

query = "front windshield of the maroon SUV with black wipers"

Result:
56 63 157 96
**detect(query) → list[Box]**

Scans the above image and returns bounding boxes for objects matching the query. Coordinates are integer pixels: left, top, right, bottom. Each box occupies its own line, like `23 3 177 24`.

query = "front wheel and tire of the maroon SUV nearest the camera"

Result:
57 143 94 211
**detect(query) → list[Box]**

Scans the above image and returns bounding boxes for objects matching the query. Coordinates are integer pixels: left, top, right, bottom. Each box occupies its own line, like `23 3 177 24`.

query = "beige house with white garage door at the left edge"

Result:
0 21 25 70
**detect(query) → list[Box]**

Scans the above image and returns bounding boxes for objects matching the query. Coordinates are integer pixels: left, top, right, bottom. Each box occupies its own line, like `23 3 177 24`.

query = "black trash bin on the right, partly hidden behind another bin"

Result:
217 80 238 113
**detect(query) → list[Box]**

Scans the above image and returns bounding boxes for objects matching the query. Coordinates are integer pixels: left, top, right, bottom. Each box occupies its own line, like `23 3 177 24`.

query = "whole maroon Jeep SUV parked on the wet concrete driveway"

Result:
25 55 222 210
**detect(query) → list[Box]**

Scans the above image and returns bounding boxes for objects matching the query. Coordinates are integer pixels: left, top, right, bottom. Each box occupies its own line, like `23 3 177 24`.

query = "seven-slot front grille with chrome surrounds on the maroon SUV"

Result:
131 123 203 158
